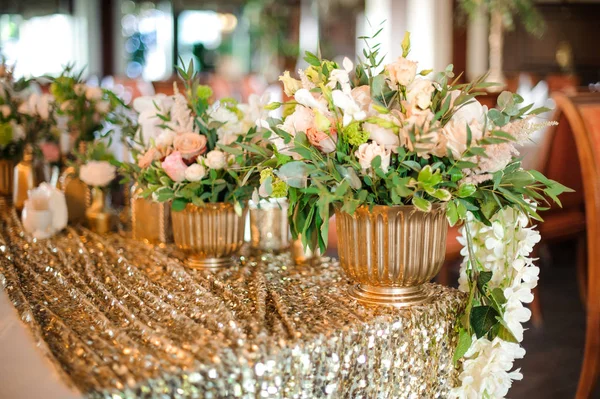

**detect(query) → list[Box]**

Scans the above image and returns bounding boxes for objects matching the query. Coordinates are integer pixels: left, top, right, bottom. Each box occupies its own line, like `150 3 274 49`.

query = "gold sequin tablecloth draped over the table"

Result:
0 211 463 399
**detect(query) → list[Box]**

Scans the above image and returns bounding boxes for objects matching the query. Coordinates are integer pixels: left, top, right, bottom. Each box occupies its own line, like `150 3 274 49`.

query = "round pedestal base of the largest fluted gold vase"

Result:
348 284 430 308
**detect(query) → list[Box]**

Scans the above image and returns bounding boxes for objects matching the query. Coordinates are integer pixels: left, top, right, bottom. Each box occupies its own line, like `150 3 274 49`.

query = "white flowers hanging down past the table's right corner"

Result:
452 208 540 399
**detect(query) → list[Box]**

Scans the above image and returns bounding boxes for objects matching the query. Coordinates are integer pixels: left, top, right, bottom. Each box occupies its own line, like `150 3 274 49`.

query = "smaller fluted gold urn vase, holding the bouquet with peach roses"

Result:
171 203 247 269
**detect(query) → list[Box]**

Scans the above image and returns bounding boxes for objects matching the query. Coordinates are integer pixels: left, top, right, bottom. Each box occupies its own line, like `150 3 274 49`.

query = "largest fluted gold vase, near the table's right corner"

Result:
336 204 448 307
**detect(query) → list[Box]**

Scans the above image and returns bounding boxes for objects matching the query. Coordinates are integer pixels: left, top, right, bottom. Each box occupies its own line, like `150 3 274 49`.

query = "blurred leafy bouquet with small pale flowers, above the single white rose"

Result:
50 66 125 144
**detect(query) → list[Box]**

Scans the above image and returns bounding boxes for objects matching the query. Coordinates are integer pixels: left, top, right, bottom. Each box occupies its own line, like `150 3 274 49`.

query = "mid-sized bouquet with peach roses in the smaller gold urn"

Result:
132 64 266 211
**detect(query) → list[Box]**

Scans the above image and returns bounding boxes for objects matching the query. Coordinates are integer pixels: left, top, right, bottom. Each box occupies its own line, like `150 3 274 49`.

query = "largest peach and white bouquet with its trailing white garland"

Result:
254 33 568 398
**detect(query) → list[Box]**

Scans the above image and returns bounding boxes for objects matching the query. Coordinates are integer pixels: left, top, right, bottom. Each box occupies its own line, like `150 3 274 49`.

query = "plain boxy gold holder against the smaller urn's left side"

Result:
130 185 173 244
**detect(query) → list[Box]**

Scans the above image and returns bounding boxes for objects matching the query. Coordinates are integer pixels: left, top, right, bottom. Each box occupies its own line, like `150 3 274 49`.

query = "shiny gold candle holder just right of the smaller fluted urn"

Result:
248 198 290 252
